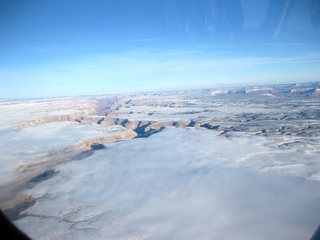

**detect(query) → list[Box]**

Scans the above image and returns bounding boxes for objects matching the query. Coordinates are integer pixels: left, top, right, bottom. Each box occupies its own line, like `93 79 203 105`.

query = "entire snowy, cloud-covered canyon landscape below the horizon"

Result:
0 82 320 239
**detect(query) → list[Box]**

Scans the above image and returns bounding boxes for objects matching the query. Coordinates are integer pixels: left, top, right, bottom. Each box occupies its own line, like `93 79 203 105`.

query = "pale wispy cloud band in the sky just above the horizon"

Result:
0 49 320 97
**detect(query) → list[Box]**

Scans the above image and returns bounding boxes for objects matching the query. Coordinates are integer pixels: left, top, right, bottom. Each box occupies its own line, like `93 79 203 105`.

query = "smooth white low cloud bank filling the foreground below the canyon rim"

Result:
15 128 320 239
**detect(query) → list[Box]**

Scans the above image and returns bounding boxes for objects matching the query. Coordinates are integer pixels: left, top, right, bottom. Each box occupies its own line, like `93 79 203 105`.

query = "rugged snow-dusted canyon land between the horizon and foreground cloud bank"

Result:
0 83 320 238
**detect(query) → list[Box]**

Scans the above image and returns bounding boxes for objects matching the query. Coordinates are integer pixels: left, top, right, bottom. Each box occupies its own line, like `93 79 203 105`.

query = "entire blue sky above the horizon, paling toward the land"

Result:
0 0 320 99
